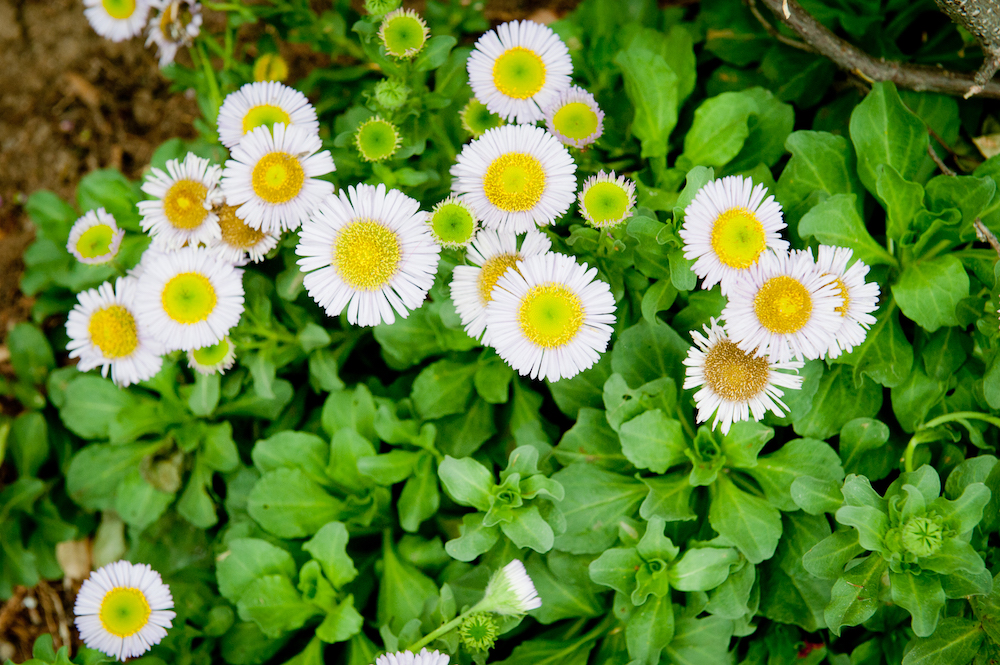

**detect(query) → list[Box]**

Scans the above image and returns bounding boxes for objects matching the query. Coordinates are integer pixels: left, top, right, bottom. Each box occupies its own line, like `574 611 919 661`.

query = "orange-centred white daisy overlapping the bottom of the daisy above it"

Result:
222 124 334 233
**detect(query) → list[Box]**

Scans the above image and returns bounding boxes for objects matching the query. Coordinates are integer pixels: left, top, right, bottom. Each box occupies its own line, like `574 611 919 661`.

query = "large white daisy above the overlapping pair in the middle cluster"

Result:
451 125 576 233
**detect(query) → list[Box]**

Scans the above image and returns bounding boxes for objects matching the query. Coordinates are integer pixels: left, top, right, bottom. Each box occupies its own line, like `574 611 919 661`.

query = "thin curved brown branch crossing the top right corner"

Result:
762 0 1000 99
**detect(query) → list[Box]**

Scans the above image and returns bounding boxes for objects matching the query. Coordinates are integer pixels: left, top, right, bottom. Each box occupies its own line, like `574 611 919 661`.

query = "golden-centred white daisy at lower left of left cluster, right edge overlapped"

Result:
66 277 164 387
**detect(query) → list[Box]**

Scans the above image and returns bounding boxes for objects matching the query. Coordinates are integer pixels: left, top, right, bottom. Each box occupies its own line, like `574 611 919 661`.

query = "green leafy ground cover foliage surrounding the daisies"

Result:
0 0 1000 665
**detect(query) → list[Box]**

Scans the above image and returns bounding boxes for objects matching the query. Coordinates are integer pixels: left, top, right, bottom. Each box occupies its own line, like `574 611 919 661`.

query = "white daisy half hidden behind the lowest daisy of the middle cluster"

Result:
451 229 552 345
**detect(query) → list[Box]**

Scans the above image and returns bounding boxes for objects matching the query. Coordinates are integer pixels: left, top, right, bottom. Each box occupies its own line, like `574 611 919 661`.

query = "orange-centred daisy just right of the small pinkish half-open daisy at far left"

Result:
139 152 222 250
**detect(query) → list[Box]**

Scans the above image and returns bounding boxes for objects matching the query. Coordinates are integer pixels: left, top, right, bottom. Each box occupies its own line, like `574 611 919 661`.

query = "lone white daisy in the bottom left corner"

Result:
73 561 177 662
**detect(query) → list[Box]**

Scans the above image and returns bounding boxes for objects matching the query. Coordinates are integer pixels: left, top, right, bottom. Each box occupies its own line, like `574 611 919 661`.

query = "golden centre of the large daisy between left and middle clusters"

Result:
331 219 401 291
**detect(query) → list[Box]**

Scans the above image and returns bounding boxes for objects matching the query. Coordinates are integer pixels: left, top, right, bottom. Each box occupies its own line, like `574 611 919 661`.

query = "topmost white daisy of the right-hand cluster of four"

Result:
679 175 788 295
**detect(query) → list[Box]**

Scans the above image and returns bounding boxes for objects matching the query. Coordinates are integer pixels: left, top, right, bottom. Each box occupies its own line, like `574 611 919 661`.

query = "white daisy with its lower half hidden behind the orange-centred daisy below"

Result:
218 81 319 148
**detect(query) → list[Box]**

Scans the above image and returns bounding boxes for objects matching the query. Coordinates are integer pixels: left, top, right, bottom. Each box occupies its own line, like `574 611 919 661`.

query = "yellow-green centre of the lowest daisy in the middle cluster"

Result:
517 284 583 349
